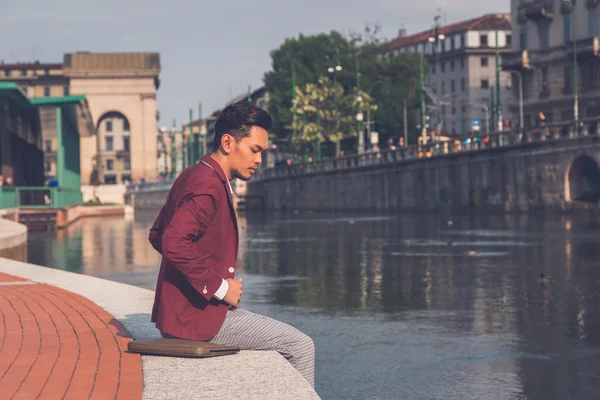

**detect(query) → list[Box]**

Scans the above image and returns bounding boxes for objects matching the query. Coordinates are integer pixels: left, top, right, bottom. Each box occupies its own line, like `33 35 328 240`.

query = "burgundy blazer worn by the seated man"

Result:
149 155 239 340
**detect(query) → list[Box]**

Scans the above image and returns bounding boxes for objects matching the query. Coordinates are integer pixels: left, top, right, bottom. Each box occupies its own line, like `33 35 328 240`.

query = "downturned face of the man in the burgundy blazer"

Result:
229 126 269 181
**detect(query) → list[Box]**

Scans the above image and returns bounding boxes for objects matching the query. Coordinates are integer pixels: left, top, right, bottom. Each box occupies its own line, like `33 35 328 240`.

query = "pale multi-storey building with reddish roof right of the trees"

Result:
386 14 514 135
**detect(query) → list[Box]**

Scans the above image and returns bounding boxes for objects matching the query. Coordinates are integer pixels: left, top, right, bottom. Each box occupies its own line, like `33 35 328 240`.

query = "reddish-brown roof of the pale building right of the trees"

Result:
388 14 511 50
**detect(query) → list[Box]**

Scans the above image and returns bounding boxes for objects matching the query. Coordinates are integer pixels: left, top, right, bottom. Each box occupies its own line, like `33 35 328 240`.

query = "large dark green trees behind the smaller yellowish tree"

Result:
264 27 419 152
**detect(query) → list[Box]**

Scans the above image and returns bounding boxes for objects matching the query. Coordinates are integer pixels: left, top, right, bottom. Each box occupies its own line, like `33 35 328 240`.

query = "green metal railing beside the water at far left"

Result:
0 186 83 209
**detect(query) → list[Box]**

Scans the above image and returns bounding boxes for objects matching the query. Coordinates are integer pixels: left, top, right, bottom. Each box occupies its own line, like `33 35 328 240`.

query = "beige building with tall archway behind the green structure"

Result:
0 52 160 185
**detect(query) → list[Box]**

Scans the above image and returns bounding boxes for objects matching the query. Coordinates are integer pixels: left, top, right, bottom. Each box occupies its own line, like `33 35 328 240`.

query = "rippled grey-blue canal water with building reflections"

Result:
28 212 600 400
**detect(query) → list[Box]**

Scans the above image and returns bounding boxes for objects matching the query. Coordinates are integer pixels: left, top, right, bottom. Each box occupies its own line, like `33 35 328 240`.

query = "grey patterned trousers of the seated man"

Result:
161 308 315 387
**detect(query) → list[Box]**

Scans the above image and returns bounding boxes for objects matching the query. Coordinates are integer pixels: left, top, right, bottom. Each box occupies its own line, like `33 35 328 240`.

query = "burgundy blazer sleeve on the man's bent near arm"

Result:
161 186 223 300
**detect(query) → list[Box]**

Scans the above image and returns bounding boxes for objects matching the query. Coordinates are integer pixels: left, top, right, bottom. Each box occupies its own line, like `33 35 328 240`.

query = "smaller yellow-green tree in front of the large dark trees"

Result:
292 76 377 155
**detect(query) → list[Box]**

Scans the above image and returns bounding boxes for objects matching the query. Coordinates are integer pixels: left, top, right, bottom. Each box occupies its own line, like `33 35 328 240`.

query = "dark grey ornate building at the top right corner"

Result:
503 0 600 127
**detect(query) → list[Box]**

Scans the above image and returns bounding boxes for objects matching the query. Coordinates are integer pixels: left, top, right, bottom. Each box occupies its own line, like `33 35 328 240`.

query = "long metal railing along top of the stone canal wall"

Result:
252 117 600 181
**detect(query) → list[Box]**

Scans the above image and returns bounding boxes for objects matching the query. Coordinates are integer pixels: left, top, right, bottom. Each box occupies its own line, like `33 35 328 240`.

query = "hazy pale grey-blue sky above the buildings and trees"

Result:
0 0 510 126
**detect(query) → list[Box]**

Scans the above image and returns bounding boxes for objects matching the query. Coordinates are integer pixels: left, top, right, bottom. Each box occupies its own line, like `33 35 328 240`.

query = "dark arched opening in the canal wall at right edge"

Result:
565 154 600 202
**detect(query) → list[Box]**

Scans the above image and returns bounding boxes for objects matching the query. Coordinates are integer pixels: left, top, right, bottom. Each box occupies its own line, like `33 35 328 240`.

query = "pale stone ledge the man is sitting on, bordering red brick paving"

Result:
0 259 319 400
